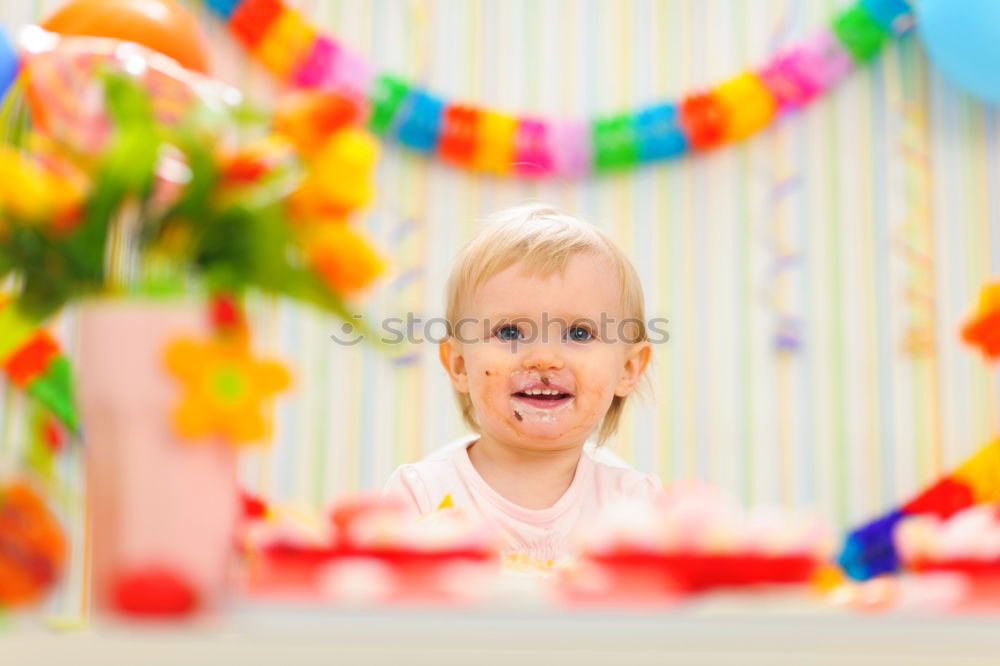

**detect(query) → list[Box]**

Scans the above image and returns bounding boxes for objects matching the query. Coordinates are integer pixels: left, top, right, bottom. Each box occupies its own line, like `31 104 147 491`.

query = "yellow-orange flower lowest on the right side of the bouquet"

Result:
303 222 386 294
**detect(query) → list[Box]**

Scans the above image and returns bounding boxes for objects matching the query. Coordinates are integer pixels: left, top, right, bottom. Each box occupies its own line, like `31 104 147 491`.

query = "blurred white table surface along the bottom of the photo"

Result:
0 596 1000 666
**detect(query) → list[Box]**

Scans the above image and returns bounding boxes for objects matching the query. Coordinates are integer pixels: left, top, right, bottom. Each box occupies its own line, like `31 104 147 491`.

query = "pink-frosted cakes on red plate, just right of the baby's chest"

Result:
561 484 833 601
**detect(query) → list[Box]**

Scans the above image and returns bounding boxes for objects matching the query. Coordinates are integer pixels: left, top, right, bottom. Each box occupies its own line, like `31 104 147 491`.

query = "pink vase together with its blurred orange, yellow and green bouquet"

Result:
0 27 386 616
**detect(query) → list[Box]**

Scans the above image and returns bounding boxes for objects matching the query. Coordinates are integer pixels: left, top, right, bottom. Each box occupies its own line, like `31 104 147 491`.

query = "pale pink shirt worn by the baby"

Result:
385 437 662 560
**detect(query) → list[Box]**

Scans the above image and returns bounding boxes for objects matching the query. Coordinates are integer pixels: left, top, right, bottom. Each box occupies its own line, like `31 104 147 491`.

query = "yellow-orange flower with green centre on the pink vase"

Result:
166 337 290 443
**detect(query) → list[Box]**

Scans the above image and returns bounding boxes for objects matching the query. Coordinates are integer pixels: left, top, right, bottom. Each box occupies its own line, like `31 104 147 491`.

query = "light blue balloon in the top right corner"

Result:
916 0 1000 102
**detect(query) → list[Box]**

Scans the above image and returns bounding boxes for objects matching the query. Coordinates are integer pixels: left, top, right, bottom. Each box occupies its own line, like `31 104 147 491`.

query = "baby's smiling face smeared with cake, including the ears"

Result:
441 254 649 449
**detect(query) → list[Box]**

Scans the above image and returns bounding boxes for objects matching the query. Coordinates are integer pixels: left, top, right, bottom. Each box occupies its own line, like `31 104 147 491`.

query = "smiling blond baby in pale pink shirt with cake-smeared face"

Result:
386 204 660 561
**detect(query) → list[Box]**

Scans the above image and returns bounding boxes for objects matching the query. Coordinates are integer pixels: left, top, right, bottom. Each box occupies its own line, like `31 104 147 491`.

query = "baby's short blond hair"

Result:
445 203 647 444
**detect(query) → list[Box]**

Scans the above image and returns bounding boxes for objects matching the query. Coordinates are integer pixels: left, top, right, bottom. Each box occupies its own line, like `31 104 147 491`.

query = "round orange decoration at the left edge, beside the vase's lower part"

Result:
0 481 66 608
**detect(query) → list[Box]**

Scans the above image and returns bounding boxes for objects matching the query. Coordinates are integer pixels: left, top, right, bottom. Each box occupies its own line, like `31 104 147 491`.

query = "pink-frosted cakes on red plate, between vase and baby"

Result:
247 494 498 603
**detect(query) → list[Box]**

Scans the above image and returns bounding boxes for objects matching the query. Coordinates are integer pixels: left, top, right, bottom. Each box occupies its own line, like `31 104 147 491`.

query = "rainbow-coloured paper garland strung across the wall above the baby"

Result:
205 0 914 178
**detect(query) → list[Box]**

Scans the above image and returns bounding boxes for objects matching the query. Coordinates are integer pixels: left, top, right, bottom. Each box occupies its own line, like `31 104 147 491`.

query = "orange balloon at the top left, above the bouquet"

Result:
42 0 208 74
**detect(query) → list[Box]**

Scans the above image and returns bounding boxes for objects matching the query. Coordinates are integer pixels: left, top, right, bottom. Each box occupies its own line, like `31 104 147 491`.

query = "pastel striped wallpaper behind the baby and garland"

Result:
0 0 1000 612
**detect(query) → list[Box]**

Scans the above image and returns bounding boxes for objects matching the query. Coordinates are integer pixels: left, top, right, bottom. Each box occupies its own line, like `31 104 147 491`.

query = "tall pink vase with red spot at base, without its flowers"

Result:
79 300 239 616
